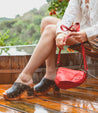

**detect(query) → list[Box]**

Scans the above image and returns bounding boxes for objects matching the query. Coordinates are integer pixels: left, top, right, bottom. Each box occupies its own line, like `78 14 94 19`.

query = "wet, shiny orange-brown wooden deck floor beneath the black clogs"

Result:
0 78 98 113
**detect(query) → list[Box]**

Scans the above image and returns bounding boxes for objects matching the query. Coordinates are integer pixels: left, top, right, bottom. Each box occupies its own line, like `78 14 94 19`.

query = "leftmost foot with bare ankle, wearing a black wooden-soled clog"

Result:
3 74 34 100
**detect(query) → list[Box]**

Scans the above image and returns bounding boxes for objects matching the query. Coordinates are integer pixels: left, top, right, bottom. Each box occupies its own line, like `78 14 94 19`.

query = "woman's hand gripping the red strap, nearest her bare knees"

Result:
56 33 67 49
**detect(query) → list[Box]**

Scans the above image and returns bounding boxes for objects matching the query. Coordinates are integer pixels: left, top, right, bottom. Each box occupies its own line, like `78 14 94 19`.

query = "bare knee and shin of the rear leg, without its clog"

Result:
41 17 60 80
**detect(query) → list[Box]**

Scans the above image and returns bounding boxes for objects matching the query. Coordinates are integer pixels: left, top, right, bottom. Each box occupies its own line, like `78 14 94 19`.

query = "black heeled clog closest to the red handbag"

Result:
34 78 60 95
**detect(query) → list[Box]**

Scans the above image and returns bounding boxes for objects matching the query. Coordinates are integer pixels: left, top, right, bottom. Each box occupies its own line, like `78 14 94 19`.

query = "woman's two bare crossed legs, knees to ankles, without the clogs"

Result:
16 17 59 85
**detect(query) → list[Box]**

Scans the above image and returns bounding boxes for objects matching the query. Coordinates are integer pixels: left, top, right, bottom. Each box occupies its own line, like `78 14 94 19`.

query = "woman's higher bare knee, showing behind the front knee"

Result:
41 16 60 33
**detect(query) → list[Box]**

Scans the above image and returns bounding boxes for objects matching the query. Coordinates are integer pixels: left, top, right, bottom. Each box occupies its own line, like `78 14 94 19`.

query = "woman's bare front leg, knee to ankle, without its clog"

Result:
16 25 56 85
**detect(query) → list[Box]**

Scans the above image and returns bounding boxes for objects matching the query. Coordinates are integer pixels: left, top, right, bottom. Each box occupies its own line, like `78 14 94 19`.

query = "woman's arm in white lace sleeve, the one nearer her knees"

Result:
56 0 81 34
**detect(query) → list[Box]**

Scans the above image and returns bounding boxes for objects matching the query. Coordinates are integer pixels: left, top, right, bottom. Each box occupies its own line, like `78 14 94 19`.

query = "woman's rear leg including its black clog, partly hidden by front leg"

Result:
34 17 59 95
